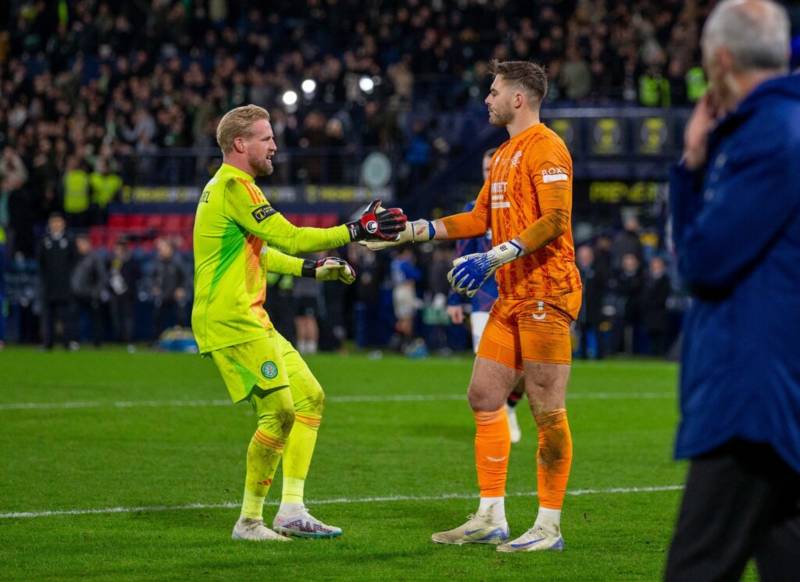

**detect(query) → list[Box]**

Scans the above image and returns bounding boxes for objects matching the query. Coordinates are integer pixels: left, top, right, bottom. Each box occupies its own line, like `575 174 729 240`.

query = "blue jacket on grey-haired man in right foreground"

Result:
670 75 800 472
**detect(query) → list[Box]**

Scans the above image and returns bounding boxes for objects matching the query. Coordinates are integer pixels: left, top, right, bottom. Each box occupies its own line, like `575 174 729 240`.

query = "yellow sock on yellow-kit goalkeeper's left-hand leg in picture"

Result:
242 429 284 519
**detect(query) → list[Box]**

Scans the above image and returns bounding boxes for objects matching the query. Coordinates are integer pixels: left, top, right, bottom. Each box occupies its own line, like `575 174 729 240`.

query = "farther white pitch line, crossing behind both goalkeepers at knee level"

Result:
0 392 675 411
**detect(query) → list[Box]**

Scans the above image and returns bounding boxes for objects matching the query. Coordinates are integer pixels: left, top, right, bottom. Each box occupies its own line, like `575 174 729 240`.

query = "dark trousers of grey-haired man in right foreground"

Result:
664 440 800 582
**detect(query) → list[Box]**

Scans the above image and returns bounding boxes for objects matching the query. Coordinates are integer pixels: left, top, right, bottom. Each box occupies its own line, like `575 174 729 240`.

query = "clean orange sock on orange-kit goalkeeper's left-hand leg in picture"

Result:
473 406 511 497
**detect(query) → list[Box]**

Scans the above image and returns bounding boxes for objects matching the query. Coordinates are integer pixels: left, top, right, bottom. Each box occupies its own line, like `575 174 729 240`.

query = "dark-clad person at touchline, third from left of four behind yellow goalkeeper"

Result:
108 239 141 352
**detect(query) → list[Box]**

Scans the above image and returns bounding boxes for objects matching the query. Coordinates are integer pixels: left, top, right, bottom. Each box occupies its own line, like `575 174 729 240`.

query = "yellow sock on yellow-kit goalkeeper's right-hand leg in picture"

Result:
281 412 321 505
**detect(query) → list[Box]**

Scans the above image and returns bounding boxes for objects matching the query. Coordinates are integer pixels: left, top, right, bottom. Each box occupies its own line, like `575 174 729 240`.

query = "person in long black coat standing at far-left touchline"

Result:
37 214 79 350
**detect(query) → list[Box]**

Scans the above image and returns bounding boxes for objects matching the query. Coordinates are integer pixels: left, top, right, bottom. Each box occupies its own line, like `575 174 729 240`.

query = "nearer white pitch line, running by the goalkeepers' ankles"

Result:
0 485 683 519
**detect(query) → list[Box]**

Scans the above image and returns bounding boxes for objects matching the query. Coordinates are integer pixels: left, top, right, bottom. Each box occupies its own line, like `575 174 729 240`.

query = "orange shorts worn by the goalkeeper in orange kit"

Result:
478 291 581 370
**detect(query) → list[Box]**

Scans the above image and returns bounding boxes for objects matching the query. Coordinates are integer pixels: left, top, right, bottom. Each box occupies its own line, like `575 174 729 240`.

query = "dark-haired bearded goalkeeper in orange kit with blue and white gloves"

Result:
367 61 581 552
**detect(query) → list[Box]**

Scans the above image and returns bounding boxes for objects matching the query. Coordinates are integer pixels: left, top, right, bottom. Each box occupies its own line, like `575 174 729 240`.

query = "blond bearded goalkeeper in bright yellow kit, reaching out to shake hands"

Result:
192 105 406 541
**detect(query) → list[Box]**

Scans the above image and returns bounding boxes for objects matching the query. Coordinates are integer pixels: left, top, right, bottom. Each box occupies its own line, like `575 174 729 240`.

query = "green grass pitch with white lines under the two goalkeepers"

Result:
0 349 752 581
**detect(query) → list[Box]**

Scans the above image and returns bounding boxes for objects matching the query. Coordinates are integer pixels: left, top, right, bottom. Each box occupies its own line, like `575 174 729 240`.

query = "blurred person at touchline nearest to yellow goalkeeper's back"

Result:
151 238 190 336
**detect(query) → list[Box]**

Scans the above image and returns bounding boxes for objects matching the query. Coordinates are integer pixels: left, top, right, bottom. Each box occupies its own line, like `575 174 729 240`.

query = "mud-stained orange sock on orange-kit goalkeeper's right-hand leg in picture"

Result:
536 408 572 509
